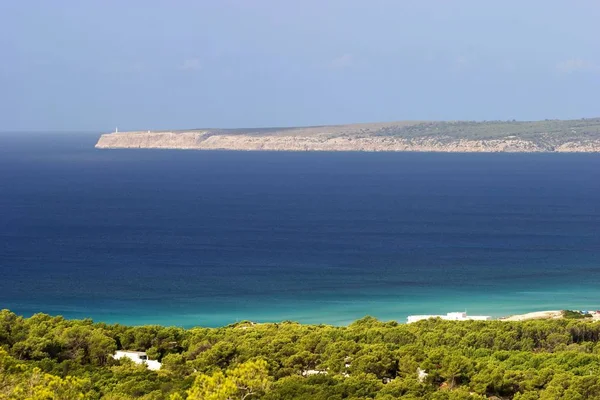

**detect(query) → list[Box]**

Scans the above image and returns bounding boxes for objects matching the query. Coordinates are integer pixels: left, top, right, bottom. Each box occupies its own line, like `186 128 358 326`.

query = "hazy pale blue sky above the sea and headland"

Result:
0 0 600 132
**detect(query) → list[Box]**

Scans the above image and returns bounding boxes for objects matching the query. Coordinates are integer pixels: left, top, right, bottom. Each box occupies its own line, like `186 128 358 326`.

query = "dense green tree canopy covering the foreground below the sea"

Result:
0 310 600 400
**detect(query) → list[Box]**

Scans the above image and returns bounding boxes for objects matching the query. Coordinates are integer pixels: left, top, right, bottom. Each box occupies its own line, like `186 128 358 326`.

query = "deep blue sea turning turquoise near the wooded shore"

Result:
0 133 600 326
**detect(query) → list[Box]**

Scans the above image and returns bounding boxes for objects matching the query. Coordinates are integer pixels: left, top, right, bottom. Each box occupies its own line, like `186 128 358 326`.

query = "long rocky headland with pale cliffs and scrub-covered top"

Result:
96 118 600 153
